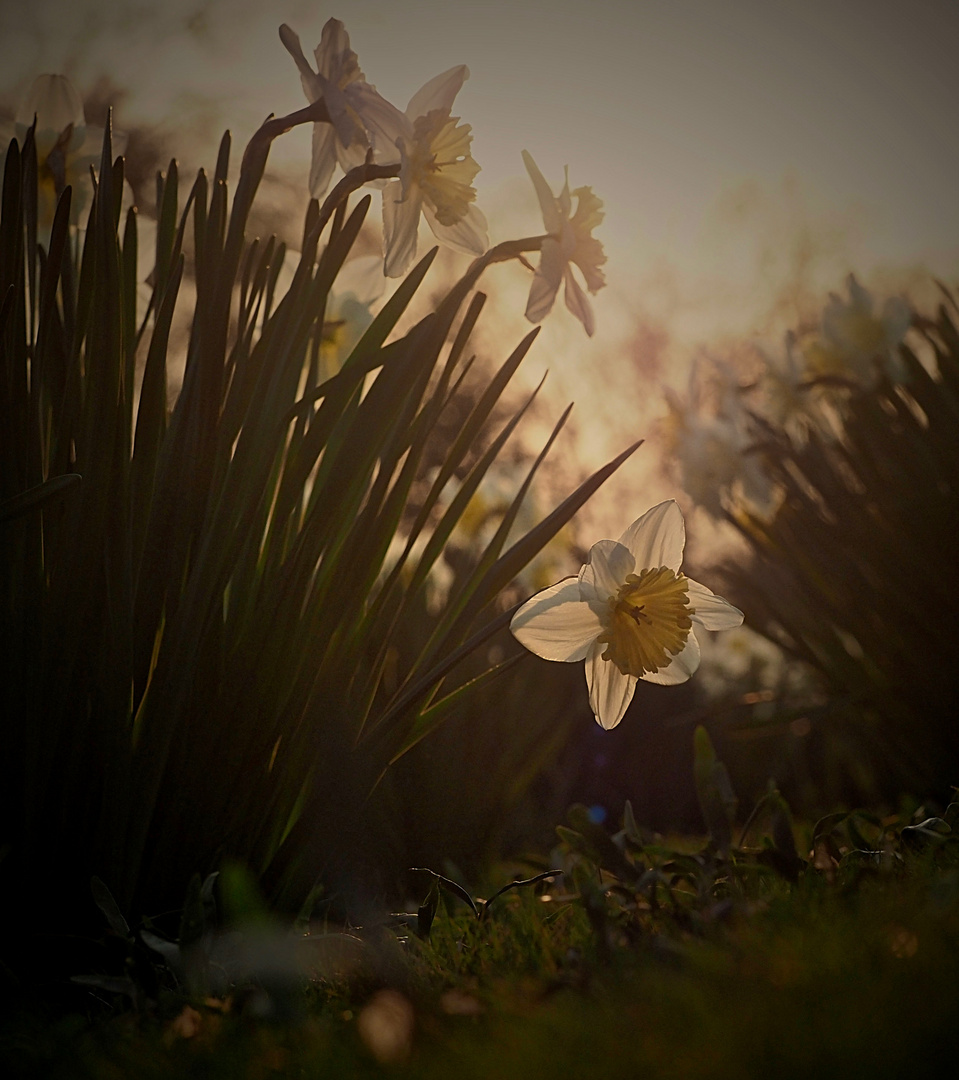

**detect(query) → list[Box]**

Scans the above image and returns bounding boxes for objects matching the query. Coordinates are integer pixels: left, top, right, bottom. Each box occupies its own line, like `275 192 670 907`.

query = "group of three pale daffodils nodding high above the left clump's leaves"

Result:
280 18 606 334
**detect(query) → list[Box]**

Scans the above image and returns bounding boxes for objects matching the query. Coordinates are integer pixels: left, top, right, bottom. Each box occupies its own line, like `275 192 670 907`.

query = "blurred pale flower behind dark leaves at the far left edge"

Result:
0 75 126 237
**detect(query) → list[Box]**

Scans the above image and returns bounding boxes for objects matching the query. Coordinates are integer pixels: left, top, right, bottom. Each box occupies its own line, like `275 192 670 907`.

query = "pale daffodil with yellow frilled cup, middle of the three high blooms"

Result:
383 64 489 278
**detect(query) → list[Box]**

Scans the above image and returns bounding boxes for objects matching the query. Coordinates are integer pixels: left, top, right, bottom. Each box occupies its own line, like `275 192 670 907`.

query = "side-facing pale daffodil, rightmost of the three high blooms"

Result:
523 150 606 336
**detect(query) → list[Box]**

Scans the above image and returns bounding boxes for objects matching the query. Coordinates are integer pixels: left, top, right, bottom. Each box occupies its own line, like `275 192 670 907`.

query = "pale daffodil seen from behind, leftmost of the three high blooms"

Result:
280 18 403 199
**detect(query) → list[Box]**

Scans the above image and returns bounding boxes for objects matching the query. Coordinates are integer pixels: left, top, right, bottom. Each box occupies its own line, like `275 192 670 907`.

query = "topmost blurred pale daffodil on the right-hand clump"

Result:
806 274 911 387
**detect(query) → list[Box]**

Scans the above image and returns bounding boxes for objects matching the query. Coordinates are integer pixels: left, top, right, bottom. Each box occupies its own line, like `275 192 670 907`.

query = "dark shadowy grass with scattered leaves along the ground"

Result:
3 777 959 1080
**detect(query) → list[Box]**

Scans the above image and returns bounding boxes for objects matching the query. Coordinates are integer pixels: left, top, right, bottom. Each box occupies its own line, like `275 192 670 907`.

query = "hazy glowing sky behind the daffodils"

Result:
0 0 959 533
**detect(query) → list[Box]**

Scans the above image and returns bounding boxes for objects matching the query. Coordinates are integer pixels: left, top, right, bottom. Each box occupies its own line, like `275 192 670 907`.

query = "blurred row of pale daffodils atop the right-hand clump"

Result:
665 274 911 518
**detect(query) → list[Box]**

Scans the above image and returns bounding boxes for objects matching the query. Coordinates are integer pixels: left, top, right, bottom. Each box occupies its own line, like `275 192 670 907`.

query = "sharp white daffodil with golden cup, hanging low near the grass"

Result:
510 501 743 729
